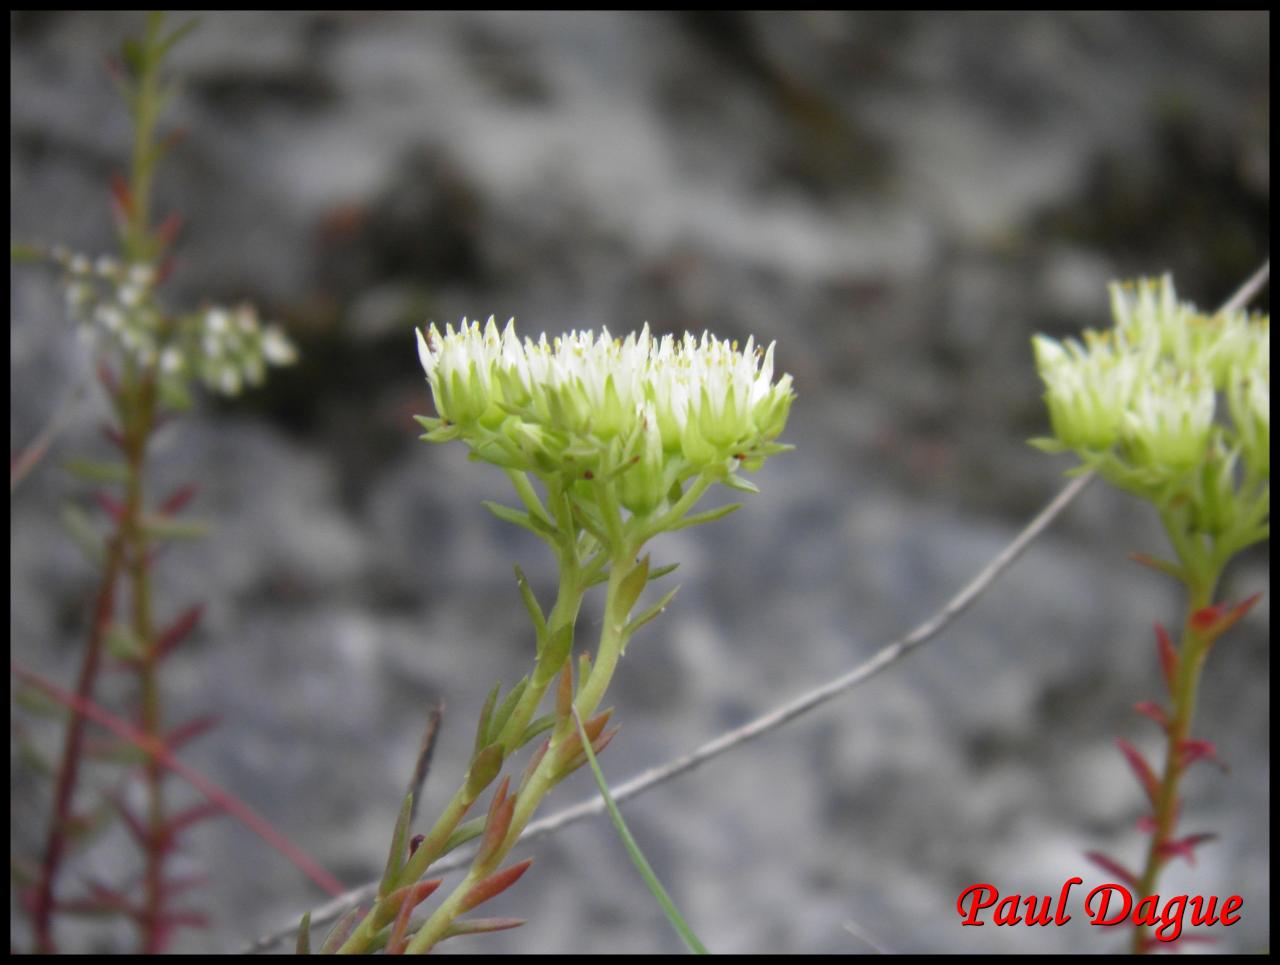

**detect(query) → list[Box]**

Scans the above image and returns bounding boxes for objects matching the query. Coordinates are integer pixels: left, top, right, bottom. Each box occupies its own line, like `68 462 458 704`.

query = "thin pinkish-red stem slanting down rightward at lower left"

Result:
9 664 346 897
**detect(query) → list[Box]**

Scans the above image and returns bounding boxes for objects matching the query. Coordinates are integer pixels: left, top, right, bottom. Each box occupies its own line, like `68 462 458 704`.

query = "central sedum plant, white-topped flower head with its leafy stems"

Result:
327 319 794 953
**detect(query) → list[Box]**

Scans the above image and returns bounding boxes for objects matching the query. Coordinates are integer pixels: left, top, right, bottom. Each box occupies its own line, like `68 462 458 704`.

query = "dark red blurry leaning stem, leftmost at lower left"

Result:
32 536 124 953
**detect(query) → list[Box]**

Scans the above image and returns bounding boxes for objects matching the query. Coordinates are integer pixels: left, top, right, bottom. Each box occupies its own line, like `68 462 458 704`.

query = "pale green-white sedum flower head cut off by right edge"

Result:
1032 276 1271 552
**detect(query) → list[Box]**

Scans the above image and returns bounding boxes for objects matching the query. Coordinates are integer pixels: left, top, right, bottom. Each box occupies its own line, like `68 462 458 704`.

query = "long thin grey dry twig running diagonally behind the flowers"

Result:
244 260 1271 953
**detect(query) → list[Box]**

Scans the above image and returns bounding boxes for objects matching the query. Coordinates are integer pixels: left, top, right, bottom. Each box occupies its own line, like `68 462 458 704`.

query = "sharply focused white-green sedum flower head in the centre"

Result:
417 319 794 516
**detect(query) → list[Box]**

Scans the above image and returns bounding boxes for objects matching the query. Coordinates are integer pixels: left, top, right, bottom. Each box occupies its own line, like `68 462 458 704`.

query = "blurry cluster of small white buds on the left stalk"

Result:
50 247 297 398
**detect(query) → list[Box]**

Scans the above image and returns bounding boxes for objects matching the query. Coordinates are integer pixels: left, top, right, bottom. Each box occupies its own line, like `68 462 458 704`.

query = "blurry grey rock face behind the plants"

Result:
9 12 1271 953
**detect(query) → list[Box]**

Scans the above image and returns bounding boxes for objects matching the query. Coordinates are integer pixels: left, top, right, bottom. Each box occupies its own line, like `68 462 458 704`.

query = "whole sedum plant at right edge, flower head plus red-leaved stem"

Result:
1032 278 1271 953
